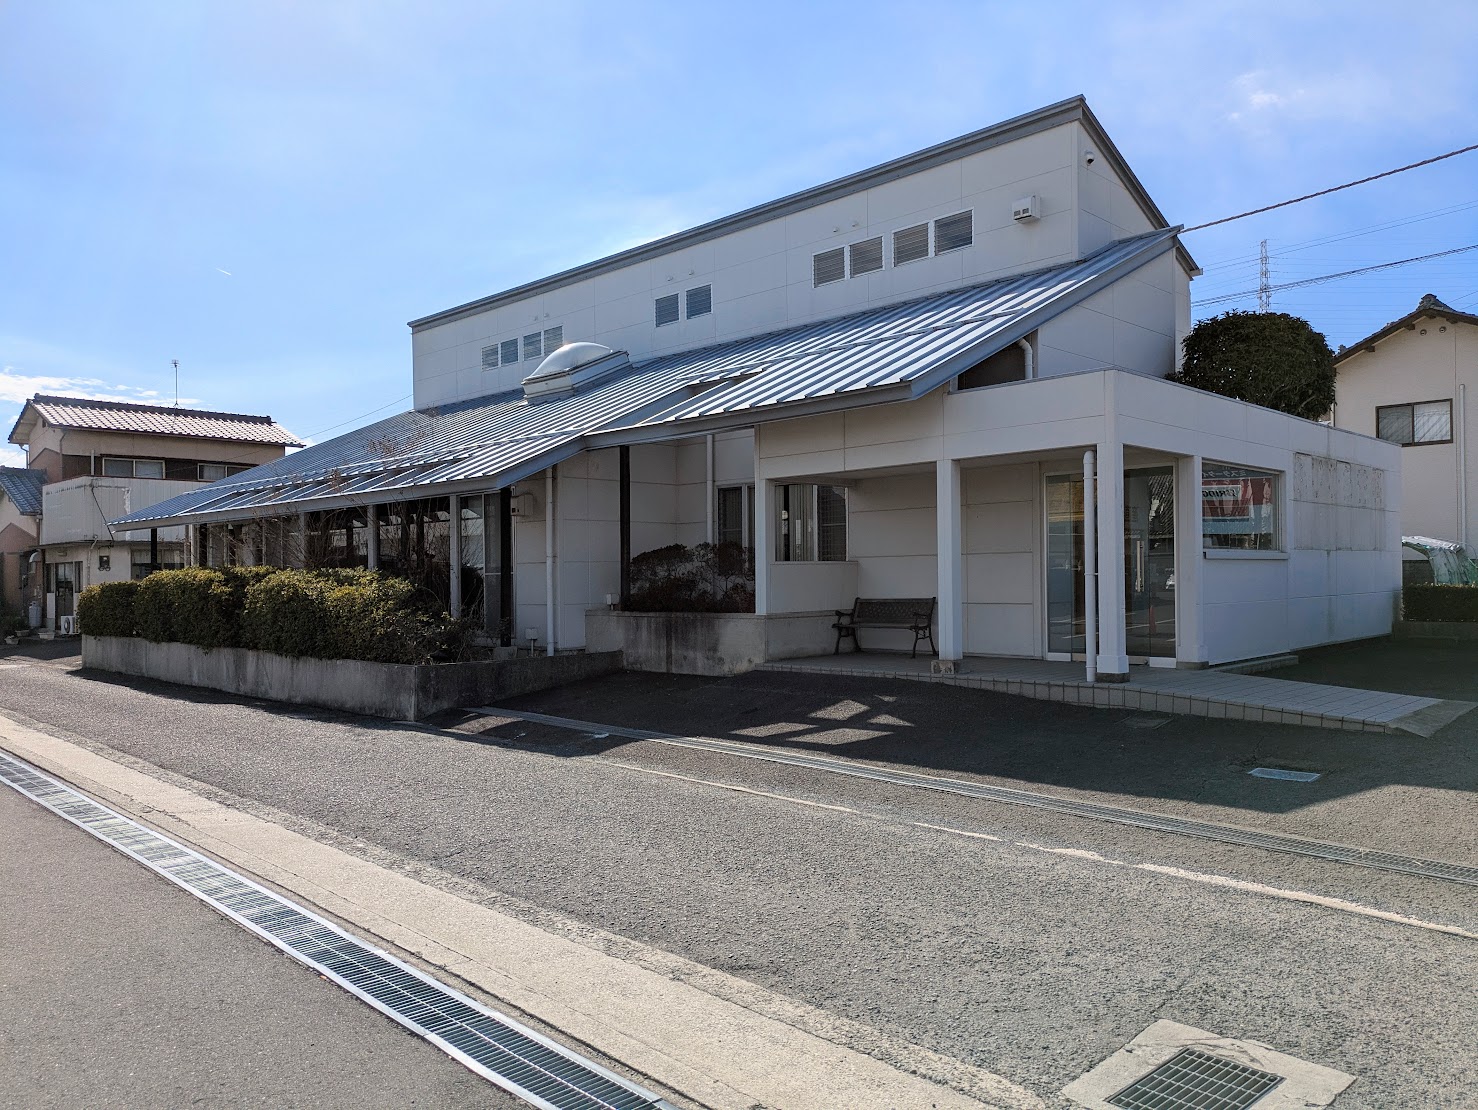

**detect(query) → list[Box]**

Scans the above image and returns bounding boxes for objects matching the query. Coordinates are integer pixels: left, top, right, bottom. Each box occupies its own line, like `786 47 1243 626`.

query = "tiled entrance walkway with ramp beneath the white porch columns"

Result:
761 652 1474 736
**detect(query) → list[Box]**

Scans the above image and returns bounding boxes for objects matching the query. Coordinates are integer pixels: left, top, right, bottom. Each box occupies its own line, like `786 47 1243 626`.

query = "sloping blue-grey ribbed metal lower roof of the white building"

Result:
114 229 1175 525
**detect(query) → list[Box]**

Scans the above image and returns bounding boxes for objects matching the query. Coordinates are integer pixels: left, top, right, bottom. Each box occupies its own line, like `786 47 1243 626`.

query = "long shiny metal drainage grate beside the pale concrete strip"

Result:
0 752 671 1110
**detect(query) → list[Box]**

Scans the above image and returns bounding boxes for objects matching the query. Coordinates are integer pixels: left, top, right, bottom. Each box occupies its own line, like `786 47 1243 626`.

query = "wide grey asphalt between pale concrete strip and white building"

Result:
0 647 1478 1110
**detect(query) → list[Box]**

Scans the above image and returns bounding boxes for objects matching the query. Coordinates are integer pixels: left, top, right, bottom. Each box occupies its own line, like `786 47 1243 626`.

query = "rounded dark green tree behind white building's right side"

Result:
1172 310 1335 420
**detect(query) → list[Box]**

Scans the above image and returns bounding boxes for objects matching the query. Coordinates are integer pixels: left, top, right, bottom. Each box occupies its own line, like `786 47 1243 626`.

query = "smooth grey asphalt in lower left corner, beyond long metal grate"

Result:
0 786 523 1110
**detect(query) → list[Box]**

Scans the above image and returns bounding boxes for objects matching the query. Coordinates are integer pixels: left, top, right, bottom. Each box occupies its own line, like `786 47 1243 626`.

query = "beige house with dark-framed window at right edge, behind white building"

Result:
1333 293 1478 544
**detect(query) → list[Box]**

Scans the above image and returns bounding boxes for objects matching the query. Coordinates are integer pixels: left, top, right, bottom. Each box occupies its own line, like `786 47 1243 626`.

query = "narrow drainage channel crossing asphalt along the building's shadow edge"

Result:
487 705 1478 887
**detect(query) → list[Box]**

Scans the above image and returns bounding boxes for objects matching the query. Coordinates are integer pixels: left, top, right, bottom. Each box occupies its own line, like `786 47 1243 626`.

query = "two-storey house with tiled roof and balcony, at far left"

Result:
10 395 299 628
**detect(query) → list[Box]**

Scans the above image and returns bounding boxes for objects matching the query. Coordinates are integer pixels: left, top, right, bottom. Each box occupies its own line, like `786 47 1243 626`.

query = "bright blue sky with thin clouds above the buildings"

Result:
0 0 1478 463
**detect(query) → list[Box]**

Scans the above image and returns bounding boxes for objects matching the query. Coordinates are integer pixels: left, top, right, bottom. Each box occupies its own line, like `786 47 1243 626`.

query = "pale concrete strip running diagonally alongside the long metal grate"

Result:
0 718 1043 1110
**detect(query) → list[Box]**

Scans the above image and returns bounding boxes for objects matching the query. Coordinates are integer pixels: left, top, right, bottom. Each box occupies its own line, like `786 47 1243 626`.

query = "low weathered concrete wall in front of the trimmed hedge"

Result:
83 636 621 721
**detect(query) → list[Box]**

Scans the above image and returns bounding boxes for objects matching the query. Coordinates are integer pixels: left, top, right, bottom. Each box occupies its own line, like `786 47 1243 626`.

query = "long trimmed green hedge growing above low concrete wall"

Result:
77 566 466 664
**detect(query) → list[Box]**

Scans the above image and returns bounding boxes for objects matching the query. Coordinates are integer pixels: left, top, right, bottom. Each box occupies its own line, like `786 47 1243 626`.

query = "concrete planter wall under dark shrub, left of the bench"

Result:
585 609 837 675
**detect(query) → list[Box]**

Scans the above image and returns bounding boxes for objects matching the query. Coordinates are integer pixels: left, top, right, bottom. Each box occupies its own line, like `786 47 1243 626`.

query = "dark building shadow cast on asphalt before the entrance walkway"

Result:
489 644 1478 819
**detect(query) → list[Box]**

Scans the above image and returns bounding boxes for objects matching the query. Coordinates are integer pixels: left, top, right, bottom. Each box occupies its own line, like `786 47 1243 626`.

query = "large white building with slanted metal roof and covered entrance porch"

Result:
120 98 1401 678
